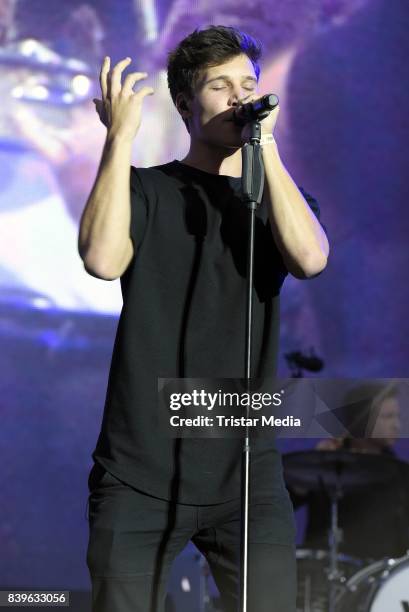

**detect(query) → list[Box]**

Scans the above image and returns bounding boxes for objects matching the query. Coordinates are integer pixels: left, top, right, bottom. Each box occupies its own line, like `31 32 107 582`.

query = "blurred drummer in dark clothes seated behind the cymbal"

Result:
290 383 409 560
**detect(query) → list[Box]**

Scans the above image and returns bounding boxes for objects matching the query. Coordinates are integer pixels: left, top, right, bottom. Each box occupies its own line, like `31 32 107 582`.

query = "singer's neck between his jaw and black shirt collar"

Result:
181 142 241 177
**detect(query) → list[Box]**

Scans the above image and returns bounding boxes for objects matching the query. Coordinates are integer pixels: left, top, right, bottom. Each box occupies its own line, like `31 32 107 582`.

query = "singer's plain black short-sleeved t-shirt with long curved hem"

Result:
93 161 319 504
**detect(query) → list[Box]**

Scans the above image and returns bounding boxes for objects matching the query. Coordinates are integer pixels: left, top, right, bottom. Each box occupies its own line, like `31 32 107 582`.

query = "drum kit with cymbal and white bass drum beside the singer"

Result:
283 450 409 612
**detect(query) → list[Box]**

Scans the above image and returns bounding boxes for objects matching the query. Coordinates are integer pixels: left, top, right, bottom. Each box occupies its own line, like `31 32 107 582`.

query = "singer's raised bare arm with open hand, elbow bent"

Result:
78 58 153 280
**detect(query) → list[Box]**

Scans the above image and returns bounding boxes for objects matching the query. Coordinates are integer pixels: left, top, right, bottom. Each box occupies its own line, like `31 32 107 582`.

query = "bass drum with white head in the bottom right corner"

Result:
340 554 409 612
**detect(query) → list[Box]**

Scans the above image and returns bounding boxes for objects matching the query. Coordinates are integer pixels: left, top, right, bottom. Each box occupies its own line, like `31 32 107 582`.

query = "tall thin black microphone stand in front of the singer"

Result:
239 119 264 612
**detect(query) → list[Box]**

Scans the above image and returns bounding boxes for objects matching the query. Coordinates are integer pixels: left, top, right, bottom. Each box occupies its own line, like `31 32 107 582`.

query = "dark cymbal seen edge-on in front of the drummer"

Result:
283 450 409 491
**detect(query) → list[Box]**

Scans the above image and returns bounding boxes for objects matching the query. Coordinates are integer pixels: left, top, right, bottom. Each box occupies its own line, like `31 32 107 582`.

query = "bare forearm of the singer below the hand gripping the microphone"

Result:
262 137 329 279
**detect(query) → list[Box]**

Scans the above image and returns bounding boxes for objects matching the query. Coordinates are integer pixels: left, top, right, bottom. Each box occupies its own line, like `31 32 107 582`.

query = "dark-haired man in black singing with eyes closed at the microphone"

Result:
79 26 328 612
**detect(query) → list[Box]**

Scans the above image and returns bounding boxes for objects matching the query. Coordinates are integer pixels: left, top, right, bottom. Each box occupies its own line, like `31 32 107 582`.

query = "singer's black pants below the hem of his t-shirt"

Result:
87 466 296 612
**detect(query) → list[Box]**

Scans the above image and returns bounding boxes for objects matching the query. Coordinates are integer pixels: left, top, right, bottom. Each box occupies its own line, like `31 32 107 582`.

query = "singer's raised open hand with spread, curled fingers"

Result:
94 57 154 141
